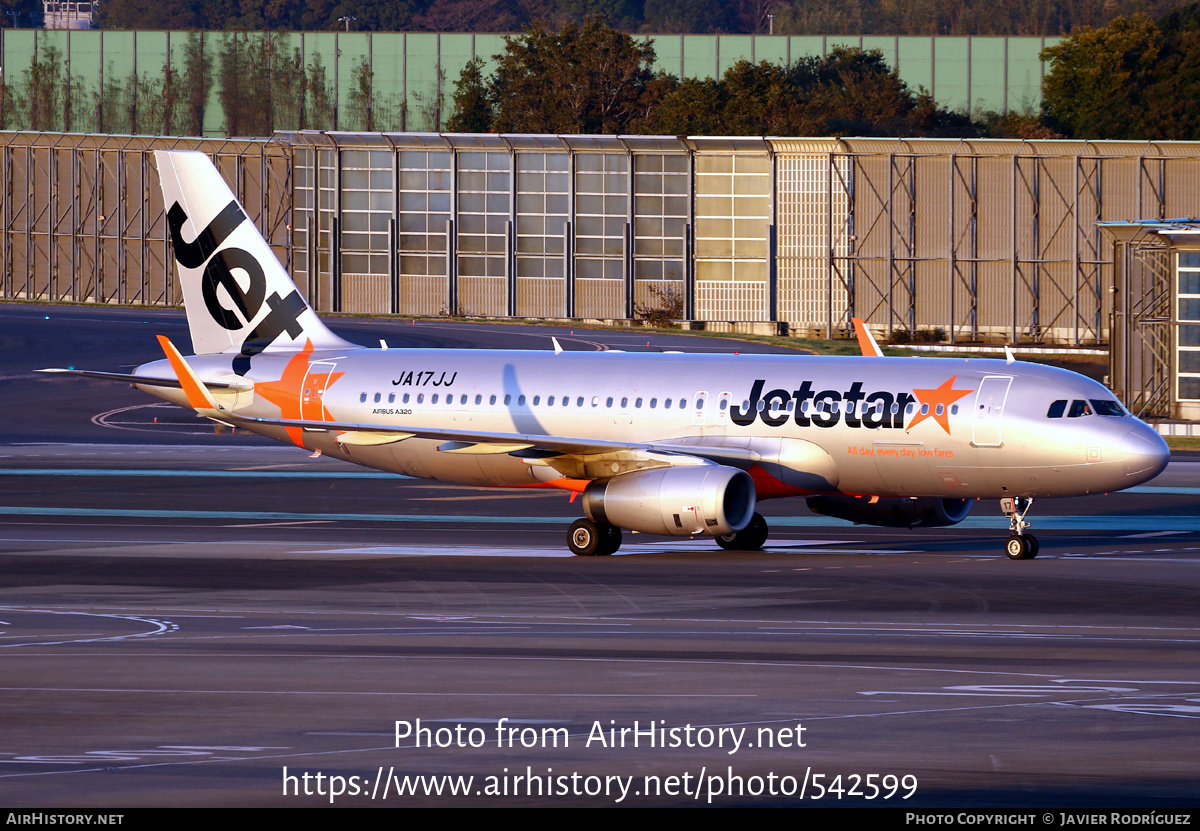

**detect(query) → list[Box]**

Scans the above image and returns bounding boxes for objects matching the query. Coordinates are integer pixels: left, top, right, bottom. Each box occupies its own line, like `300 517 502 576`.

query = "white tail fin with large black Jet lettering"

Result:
155 150 353 375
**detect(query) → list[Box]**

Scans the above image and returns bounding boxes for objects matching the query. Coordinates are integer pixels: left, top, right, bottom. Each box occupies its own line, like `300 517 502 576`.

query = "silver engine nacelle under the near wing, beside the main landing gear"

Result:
583 465 756 537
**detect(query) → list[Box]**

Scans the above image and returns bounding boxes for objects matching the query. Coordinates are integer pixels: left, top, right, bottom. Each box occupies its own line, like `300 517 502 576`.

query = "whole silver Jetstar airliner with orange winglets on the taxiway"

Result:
39 151 1169 560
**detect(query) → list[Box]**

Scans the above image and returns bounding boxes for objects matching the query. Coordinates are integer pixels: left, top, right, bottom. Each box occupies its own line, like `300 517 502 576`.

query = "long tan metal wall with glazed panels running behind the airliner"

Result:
0 131 1200 419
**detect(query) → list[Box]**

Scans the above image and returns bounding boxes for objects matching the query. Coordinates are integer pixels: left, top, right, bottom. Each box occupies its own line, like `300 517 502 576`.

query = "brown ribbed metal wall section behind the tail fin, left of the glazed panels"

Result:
0 133 285 305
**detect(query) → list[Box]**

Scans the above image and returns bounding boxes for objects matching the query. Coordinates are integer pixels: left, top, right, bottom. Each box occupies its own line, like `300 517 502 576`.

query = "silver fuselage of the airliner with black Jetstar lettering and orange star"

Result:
138 349 1165 498
